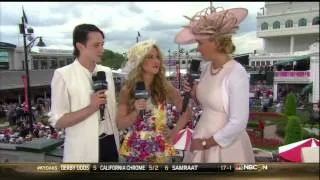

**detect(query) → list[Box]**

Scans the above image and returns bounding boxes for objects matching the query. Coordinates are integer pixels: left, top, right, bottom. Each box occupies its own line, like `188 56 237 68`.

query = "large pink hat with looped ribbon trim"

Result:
175 7 248 44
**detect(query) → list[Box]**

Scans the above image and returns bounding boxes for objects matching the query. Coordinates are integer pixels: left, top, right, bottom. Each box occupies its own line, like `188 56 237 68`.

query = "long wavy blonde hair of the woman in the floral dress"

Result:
125 44 170 111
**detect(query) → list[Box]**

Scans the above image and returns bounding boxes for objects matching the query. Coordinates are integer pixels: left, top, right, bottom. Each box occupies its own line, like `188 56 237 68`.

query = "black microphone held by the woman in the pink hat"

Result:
181 59 200 114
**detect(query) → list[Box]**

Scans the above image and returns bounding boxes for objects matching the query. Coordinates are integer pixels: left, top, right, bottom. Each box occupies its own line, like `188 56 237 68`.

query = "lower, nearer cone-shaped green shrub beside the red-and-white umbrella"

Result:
284 116 302 145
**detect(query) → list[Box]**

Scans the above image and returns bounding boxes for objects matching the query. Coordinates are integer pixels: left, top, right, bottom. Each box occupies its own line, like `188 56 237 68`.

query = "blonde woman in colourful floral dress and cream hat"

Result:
116 40 191 163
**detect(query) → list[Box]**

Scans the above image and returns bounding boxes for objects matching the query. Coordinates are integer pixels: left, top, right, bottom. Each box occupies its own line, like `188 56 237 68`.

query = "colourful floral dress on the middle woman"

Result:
120 103 175 163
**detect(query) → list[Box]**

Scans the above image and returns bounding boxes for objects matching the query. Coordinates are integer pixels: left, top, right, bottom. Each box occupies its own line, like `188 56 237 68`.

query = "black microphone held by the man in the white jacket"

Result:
92 71 108 121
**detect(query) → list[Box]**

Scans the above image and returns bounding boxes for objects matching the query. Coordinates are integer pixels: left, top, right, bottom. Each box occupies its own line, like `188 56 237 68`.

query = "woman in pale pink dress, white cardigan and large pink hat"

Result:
175 7 255 163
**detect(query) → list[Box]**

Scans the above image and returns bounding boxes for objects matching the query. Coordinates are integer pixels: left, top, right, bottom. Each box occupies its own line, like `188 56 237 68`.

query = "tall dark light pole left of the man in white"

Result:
19 16 45 135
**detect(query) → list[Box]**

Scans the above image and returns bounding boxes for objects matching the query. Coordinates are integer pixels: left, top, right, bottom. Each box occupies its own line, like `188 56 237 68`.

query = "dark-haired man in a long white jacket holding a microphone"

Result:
49 24 119 162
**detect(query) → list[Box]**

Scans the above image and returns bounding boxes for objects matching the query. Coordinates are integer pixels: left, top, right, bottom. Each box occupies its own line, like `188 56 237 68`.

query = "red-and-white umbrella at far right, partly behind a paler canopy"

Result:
279 138 319 162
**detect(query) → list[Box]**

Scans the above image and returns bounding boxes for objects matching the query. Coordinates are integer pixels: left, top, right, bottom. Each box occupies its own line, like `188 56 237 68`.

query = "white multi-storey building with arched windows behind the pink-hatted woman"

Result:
249 2 320 103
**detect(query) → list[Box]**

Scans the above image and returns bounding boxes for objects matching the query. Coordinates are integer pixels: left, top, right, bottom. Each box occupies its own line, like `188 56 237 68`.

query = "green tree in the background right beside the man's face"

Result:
101 49 127 69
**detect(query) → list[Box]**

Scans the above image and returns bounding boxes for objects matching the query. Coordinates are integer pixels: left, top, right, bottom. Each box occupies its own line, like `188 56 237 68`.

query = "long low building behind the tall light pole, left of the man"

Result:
0 46 73 104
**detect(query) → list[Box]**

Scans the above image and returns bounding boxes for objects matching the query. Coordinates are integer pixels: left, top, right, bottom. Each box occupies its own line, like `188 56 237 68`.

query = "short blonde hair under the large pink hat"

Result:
210 35 236 54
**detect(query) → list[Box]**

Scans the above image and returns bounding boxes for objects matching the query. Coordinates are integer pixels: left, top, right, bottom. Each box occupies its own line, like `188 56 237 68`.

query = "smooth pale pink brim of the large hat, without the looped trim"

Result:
175 8 248 45
